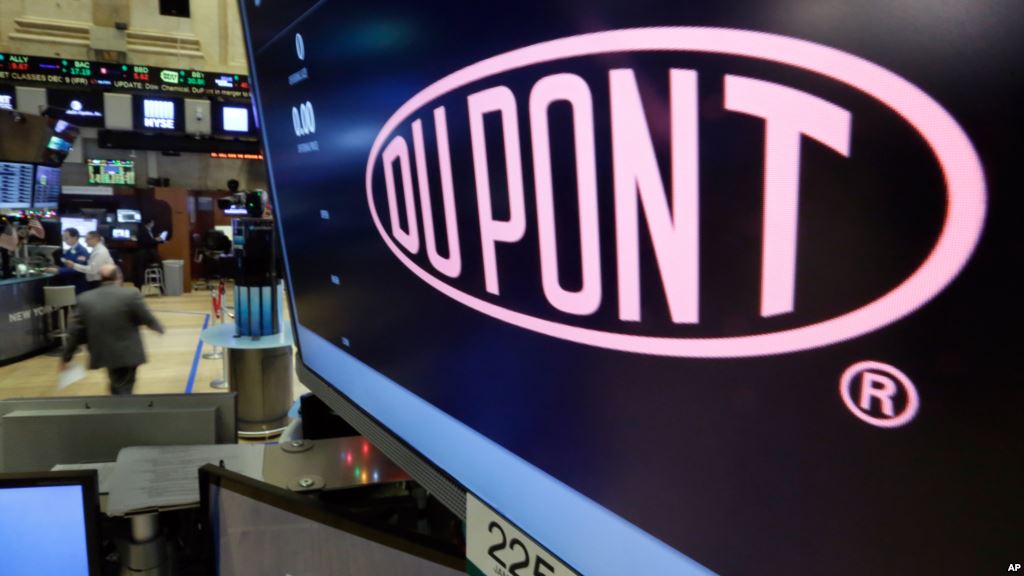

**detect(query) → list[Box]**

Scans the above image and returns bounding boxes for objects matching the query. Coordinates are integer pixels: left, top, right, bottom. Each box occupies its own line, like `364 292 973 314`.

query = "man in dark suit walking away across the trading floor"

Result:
60 264 164 395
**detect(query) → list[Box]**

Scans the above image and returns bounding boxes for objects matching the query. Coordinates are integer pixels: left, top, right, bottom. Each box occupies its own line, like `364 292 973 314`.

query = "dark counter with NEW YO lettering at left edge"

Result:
0 274 55 365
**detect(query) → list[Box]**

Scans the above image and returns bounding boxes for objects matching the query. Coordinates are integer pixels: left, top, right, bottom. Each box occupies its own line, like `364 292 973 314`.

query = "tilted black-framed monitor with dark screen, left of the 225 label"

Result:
199 464 466 576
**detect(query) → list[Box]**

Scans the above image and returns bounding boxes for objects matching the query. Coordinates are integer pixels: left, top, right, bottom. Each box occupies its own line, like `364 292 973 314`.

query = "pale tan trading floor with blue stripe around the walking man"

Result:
0 290 306 400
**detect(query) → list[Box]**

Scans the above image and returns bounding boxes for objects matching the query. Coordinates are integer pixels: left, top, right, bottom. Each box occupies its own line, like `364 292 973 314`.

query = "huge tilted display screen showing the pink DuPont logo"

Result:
242 0 1024 575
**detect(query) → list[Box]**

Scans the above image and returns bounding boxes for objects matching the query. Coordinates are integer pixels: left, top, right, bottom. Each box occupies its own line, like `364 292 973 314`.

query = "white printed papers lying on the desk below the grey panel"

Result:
106 444 264 516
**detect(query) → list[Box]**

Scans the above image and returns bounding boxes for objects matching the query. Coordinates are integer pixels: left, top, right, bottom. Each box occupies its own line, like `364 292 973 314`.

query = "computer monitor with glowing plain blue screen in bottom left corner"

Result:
0 470 101 576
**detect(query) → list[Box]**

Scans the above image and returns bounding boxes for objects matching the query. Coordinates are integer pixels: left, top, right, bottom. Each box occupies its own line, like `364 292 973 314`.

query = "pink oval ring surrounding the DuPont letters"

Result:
366 27 987 358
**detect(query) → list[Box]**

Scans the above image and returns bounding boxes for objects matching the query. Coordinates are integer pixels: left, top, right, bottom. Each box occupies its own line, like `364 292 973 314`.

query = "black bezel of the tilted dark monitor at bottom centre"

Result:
199 464 466 574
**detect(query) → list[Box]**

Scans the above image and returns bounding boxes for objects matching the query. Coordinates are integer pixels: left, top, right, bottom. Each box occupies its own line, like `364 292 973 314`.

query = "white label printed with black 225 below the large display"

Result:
466 494 580 576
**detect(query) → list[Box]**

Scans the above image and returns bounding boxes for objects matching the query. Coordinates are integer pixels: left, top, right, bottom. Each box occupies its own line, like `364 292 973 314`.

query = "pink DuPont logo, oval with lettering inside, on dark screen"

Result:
366 28 986 358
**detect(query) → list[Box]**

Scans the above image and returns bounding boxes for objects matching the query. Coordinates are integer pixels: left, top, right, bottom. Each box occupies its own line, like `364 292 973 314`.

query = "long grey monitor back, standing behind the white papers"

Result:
0 393 238 471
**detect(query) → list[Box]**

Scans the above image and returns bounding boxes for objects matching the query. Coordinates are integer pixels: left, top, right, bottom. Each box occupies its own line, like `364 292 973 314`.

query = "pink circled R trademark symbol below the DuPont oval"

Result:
839 360 921 428
